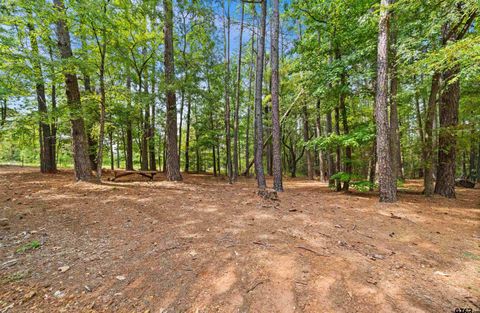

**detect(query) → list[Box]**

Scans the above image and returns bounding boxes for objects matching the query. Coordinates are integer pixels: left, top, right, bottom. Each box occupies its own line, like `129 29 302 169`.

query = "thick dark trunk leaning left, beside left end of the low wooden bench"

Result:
53 0 92 181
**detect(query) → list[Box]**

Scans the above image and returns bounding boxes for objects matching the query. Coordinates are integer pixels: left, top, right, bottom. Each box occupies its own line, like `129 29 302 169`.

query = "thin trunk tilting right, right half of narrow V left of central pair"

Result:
233 2 245 180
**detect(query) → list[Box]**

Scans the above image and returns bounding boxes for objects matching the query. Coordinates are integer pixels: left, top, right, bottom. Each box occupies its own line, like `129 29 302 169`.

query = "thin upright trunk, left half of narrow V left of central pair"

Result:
222 0 233 183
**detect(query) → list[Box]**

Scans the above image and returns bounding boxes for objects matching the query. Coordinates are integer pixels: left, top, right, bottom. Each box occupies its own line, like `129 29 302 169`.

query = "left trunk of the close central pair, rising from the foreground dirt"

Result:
255 0 267 190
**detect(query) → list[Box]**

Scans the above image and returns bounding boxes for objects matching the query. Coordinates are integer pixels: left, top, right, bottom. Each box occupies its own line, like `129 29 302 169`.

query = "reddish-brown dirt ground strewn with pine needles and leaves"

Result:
0 167 480 313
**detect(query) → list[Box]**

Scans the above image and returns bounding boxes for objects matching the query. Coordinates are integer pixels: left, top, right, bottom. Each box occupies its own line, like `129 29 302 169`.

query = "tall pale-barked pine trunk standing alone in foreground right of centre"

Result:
375 0 397 202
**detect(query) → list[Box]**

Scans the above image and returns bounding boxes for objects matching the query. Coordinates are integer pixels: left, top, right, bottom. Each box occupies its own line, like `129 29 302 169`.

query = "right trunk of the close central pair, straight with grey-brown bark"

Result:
270 0 283 191
